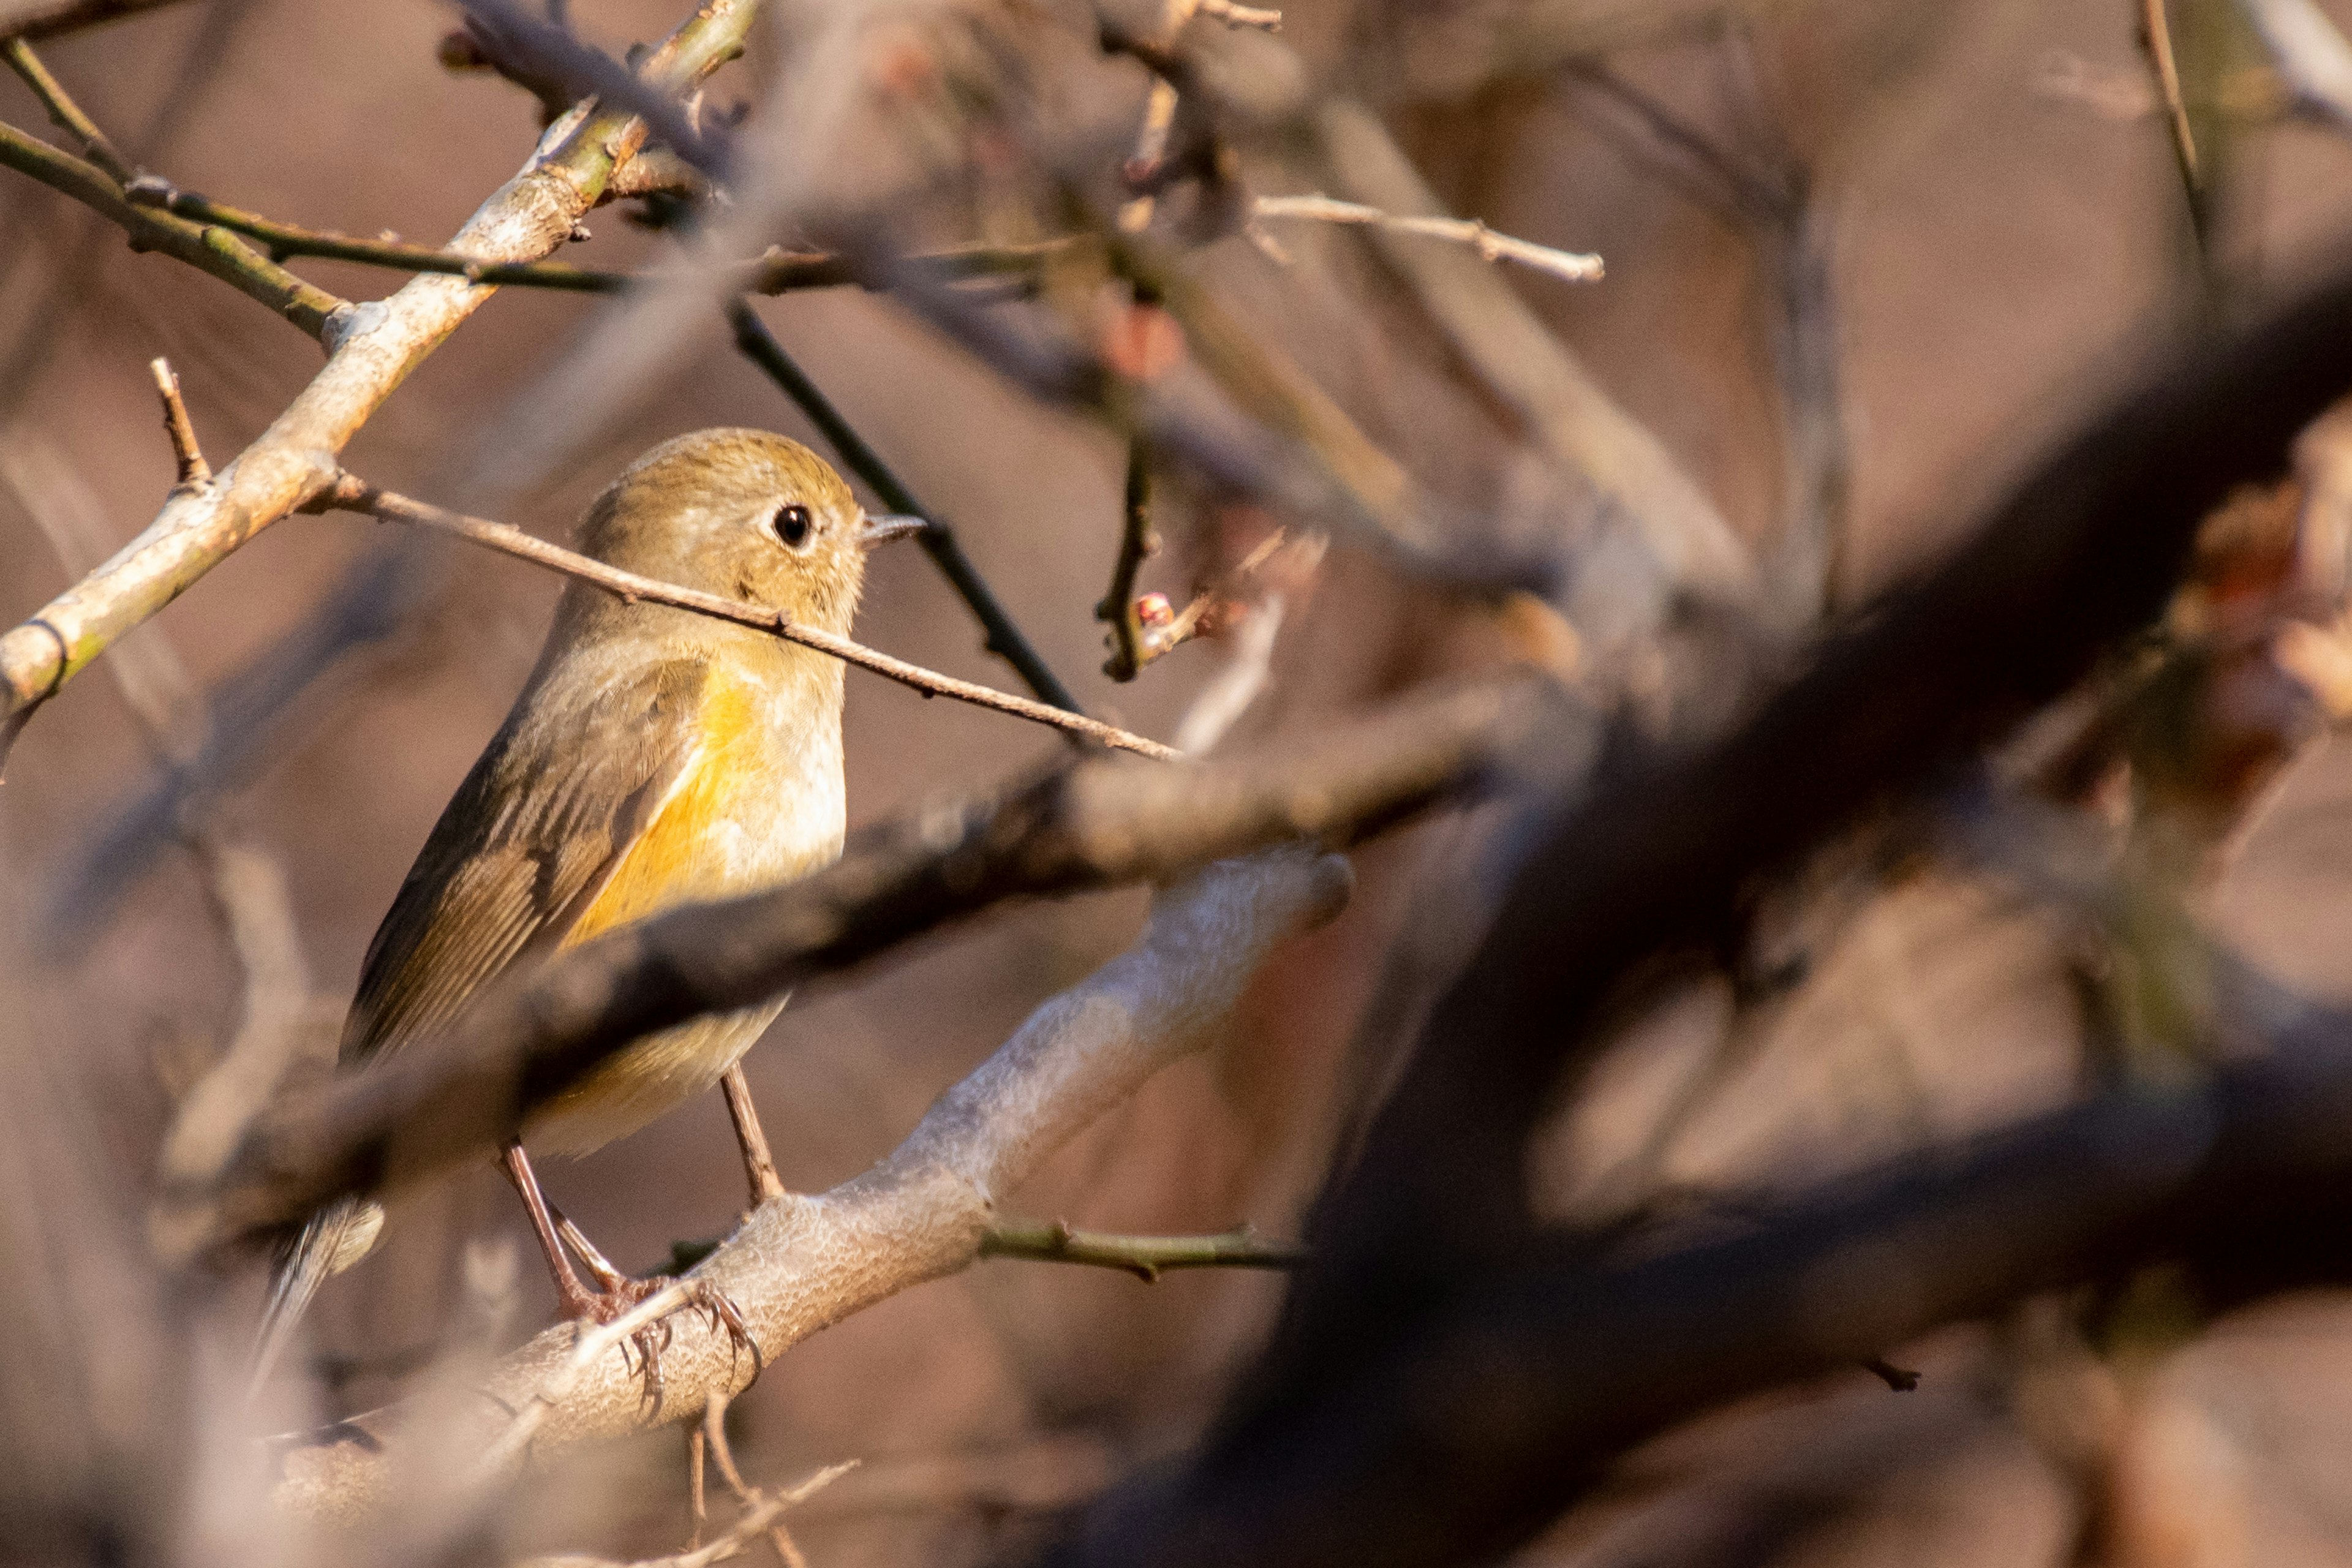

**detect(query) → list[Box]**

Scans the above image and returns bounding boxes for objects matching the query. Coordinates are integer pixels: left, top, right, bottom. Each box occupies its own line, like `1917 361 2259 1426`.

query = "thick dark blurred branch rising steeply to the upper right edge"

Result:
1039 251 2352 1568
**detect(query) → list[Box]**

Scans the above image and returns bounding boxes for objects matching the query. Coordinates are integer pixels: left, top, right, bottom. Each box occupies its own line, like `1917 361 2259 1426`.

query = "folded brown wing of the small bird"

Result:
344 658 710 1063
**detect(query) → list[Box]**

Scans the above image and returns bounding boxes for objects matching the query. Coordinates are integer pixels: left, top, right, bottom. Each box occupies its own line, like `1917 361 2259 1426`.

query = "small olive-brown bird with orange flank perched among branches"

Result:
254 430 924 1389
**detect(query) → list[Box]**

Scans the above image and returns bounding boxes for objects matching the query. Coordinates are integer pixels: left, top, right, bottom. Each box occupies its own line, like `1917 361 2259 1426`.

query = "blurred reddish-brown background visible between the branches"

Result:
13 0 2352 1568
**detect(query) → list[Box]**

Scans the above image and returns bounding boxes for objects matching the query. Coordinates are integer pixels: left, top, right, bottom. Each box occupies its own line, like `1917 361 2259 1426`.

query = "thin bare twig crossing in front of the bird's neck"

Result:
317 472 1183 762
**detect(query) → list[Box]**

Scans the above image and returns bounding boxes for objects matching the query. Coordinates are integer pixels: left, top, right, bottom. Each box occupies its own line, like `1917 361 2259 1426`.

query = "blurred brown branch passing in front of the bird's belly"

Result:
157 677 1543 1256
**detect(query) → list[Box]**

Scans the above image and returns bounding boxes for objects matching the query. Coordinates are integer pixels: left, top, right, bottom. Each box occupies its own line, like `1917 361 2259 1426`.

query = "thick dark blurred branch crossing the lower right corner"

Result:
1049 982 2352 1568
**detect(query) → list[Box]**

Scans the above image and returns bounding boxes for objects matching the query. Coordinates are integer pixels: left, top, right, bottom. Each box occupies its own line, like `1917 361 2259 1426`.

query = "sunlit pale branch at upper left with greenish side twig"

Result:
0 0 753 761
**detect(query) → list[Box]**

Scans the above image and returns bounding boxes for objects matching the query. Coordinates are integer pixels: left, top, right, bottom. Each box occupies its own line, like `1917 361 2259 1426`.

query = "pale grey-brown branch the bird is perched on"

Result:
262 849 1348 1518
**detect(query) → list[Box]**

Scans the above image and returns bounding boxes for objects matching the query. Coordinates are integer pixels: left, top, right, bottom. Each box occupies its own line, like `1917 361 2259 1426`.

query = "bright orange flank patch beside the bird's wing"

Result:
562 670 767 948
